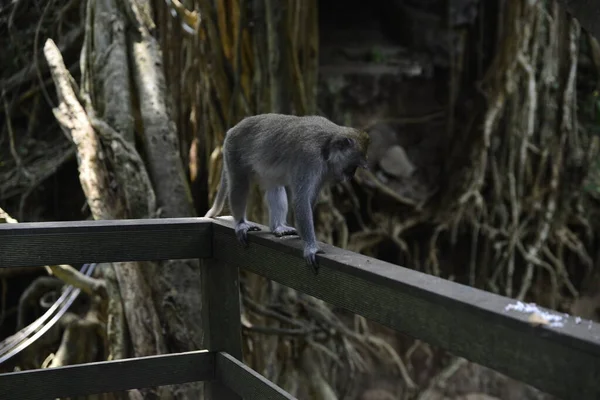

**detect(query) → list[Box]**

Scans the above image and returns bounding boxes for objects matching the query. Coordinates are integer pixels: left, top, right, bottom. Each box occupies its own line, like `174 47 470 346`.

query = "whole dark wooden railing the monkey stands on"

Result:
0 218 600 400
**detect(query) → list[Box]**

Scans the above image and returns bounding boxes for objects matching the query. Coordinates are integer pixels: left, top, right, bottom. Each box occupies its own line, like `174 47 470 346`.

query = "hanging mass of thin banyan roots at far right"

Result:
463 2 594 307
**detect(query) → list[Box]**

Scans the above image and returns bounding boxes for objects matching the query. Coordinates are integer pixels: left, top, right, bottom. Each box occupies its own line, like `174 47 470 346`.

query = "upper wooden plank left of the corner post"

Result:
0 218 212 268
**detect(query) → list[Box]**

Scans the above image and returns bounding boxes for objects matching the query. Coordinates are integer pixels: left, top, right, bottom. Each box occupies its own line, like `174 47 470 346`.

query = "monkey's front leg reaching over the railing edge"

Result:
294 186 323 274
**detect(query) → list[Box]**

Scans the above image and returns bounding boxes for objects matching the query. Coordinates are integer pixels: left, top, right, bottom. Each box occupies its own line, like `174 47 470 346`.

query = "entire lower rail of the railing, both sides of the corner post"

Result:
0 350 294 400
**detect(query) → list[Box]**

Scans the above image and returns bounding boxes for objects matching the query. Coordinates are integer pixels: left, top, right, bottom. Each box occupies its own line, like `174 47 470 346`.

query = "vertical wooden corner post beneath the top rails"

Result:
201 255 243 400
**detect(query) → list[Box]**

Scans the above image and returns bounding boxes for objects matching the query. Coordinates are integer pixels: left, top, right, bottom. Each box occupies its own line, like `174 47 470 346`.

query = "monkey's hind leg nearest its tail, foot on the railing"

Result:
229 171 260 246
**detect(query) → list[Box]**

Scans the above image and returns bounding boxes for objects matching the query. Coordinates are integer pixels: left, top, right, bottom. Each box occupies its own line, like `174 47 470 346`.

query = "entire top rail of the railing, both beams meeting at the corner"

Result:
0 218 600 399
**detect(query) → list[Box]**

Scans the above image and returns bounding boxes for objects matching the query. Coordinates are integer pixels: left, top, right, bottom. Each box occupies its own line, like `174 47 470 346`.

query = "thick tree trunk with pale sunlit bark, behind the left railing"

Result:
47 0 203 399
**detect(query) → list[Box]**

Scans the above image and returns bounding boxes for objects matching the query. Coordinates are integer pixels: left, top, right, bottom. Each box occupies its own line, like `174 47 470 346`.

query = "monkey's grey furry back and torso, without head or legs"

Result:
223 114 348 188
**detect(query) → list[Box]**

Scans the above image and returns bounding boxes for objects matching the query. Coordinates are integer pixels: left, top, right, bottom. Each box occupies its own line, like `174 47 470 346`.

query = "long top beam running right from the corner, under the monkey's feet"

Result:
213 218 600 399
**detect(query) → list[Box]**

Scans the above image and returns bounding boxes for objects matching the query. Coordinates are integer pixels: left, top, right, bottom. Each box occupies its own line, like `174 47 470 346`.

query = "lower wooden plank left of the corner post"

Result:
0 350 216 400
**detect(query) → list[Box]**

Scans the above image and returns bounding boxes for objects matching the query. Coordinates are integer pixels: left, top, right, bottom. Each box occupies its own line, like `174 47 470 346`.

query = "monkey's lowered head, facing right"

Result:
324 129 371 181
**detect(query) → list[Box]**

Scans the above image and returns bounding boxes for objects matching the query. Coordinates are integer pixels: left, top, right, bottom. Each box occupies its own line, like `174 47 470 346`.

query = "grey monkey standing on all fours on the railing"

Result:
205 114 370 273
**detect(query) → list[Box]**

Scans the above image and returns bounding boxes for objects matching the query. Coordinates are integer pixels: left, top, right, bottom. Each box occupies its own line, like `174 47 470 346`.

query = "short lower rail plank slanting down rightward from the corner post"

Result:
215 353 296 400
